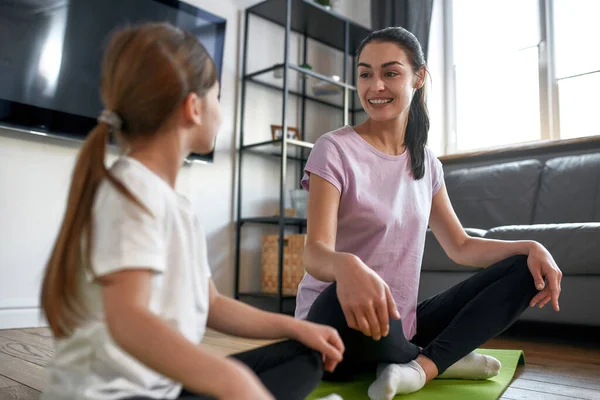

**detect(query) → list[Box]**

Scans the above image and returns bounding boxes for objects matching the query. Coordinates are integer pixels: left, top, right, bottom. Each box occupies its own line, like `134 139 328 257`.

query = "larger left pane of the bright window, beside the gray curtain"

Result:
452 0 540 152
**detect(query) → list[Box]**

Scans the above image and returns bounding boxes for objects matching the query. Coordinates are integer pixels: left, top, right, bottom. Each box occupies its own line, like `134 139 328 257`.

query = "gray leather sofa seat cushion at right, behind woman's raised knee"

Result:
485 222 600 275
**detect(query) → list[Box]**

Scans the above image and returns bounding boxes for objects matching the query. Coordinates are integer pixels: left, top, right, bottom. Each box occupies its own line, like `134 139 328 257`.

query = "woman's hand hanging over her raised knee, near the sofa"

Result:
527 242 562 311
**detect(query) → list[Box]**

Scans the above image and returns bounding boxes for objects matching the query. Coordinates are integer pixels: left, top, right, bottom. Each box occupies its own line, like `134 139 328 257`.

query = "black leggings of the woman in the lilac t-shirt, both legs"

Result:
307 256 537 381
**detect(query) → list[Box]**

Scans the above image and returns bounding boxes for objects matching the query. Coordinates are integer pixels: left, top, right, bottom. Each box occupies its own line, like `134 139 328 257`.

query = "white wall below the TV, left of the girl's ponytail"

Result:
0 131 76 328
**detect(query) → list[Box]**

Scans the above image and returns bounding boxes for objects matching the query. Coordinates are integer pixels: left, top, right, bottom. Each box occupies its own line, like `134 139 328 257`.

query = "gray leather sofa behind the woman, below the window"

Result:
419 152 600 326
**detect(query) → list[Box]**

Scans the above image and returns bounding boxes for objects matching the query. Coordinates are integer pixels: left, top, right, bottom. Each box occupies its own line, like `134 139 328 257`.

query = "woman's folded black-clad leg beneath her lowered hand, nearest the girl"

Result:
307 282 419 381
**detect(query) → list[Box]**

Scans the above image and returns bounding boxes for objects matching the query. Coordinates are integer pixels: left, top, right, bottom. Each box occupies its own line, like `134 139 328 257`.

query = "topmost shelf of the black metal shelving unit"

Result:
248 0 370 54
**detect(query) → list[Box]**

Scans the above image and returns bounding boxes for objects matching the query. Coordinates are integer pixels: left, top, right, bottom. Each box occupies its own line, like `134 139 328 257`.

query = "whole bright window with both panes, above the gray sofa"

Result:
445 0 600 153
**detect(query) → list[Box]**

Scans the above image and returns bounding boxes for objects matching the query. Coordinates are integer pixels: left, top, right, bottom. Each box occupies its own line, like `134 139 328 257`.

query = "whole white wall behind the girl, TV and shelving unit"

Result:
0 0 369 329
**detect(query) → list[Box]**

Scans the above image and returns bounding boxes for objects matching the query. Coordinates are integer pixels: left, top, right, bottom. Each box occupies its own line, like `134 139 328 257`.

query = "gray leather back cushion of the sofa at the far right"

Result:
534 154 600 224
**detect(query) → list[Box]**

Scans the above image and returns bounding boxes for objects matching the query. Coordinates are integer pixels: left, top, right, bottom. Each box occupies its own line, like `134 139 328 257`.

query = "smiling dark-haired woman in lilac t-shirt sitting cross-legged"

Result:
296 28 562 400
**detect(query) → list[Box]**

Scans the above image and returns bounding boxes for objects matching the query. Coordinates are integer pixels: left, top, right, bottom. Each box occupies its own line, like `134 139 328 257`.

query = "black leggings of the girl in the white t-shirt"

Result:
127 340 323 400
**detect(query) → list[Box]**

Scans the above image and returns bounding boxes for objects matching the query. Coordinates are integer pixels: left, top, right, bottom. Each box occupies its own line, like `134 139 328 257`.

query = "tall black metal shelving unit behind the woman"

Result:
234 0 370 314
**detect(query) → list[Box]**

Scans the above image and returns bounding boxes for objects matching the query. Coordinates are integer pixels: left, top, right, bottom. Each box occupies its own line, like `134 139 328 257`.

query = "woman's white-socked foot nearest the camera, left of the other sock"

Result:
369 360 425 400
